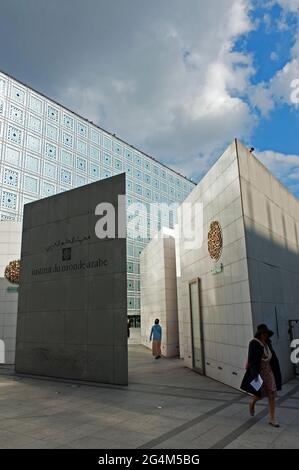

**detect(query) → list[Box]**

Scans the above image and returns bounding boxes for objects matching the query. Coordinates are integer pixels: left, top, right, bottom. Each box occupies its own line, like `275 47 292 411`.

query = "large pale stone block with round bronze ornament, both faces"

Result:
178 141 299 388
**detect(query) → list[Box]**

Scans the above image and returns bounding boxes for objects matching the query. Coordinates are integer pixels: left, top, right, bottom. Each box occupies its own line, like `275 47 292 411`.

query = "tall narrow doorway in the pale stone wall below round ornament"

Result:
189 278 205 374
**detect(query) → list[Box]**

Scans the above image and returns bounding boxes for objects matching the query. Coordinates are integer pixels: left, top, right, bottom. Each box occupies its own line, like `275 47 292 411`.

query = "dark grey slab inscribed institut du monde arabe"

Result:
16 174 128 384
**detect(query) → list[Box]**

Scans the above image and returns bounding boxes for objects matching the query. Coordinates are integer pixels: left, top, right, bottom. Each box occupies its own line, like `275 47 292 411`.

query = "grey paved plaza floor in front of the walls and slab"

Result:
0 345 299 449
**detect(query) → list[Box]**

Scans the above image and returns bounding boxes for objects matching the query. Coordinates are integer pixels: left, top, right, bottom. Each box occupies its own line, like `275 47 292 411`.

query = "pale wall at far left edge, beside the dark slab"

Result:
0 221 22 364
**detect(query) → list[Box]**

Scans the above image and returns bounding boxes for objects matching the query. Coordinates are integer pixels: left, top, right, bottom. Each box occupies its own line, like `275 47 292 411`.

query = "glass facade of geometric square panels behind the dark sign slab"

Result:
0 73 194 315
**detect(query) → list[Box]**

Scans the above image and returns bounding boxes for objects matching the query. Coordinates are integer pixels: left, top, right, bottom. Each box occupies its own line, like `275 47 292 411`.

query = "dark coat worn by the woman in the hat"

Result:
240 339 281 398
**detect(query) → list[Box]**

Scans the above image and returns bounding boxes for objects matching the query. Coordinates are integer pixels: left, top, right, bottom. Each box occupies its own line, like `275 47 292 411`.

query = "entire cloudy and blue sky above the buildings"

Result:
0 0 299 196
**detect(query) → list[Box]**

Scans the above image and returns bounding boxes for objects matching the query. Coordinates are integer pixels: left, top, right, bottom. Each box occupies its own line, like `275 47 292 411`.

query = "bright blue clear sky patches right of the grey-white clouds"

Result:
241 0 299 196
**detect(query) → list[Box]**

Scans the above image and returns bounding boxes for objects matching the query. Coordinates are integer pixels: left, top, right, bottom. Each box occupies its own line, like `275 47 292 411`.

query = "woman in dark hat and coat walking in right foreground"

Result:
241 324 281 428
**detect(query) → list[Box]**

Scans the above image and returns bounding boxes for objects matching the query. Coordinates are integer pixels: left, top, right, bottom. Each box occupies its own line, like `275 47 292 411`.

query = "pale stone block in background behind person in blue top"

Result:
140 234 179 357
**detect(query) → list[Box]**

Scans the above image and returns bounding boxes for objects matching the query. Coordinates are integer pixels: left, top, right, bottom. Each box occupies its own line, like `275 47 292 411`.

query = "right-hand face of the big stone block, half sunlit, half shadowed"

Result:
238 143 299 380
